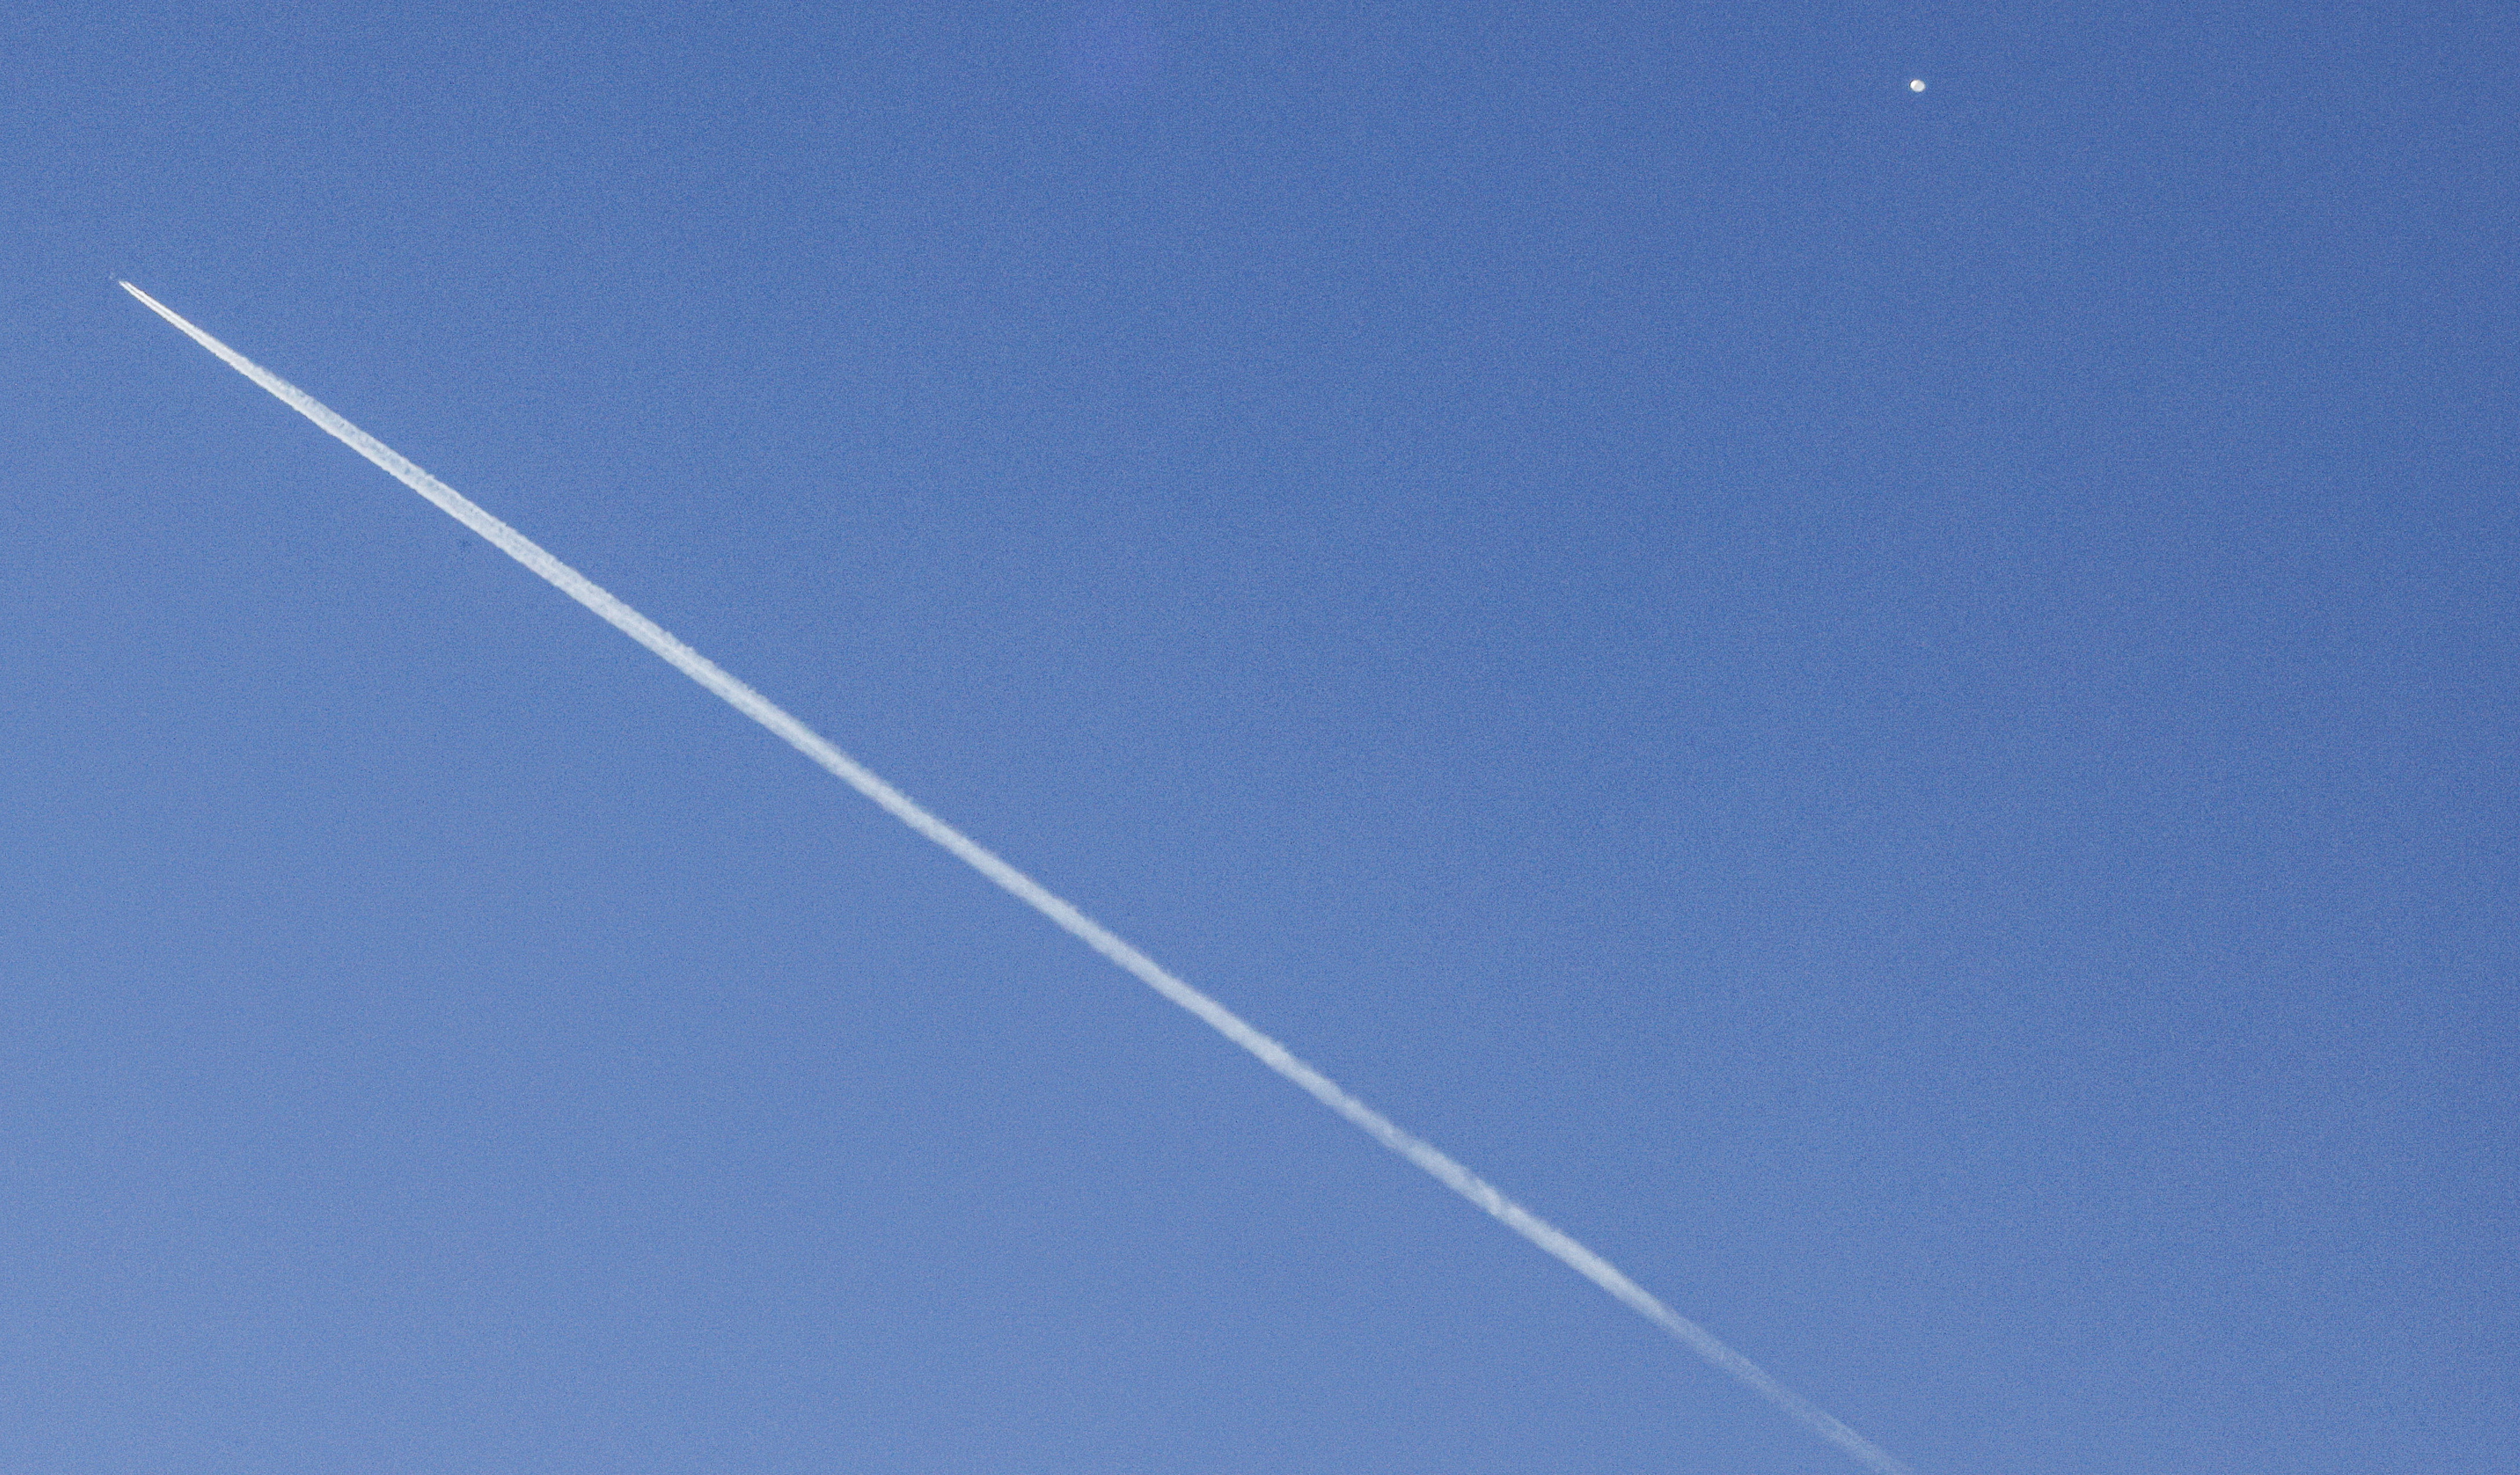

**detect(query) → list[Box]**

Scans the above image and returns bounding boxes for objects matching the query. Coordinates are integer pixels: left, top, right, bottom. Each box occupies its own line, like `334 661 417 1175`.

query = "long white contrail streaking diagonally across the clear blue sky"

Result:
121 283 1910 1475
